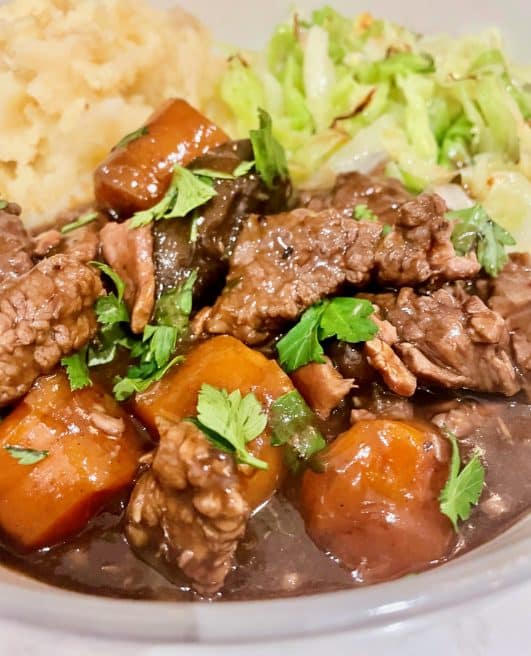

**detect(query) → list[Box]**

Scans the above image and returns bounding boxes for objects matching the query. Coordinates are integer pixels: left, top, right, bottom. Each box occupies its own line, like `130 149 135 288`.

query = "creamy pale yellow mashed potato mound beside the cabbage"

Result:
0 0 222 226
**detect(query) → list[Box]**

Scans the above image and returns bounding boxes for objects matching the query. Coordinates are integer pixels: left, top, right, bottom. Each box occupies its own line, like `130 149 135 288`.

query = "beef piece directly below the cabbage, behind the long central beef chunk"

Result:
297 172 414 225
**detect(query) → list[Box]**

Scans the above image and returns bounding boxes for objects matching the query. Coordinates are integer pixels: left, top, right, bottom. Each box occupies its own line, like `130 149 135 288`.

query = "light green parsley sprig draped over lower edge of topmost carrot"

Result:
130 164 217 229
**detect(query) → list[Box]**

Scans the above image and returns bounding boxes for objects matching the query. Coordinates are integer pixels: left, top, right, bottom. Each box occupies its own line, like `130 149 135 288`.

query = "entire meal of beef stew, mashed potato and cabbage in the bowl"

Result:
0 0 531 601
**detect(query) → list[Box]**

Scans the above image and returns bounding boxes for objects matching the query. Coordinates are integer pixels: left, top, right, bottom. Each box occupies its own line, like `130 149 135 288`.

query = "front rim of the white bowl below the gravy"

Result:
0 515 531 645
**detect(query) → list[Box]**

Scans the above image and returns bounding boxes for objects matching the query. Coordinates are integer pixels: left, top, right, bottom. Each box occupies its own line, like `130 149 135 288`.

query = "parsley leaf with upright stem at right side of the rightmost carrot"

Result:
439 430 485 531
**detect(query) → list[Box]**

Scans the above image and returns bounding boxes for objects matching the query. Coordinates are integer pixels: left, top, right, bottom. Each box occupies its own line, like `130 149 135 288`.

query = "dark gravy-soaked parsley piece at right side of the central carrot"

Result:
269 390 326 470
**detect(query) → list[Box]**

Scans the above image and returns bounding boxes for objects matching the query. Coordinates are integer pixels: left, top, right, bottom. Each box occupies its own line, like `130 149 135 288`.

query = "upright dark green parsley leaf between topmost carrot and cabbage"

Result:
249 108 288 188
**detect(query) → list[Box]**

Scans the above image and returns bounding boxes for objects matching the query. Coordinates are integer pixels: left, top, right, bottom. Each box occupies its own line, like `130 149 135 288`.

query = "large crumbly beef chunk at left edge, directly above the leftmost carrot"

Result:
0 255 101 406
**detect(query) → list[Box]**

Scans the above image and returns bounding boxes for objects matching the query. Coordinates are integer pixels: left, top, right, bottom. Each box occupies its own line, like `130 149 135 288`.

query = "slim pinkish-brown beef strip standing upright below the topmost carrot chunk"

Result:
100 221 155 333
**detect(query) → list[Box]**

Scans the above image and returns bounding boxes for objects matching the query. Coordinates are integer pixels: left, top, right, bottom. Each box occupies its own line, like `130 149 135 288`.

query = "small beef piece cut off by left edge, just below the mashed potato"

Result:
0 203 33 290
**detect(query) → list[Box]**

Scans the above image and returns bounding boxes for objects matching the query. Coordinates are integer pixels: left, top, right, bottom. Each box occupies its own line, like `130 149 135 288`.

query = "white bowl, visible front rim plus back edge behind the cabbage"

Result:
0 0 531 643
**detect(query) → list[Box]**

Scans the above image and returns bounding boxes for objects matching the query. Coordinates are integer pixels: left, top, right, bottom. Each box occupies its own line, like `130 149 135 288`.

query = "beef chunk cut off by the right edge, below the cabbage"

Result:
488 253 531 374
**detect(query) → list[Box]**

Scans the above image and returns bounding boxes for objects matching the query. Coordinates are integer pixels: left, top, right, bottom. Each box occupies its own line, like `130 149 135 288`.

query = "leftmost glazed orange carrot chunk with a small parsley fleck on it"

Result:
0 371 143 550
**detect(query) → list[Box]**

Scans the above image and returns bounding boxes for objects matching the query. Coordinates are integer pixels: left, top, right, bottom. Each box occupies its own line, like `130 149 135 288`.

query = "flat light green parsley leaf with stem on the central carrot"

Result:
191 383 268 469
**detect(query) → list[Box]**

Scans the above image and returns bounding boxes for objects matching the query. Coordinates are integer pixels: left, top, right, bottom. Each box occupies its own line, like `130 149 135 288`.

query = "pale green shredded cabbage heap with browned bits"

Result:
215 7 531 246
